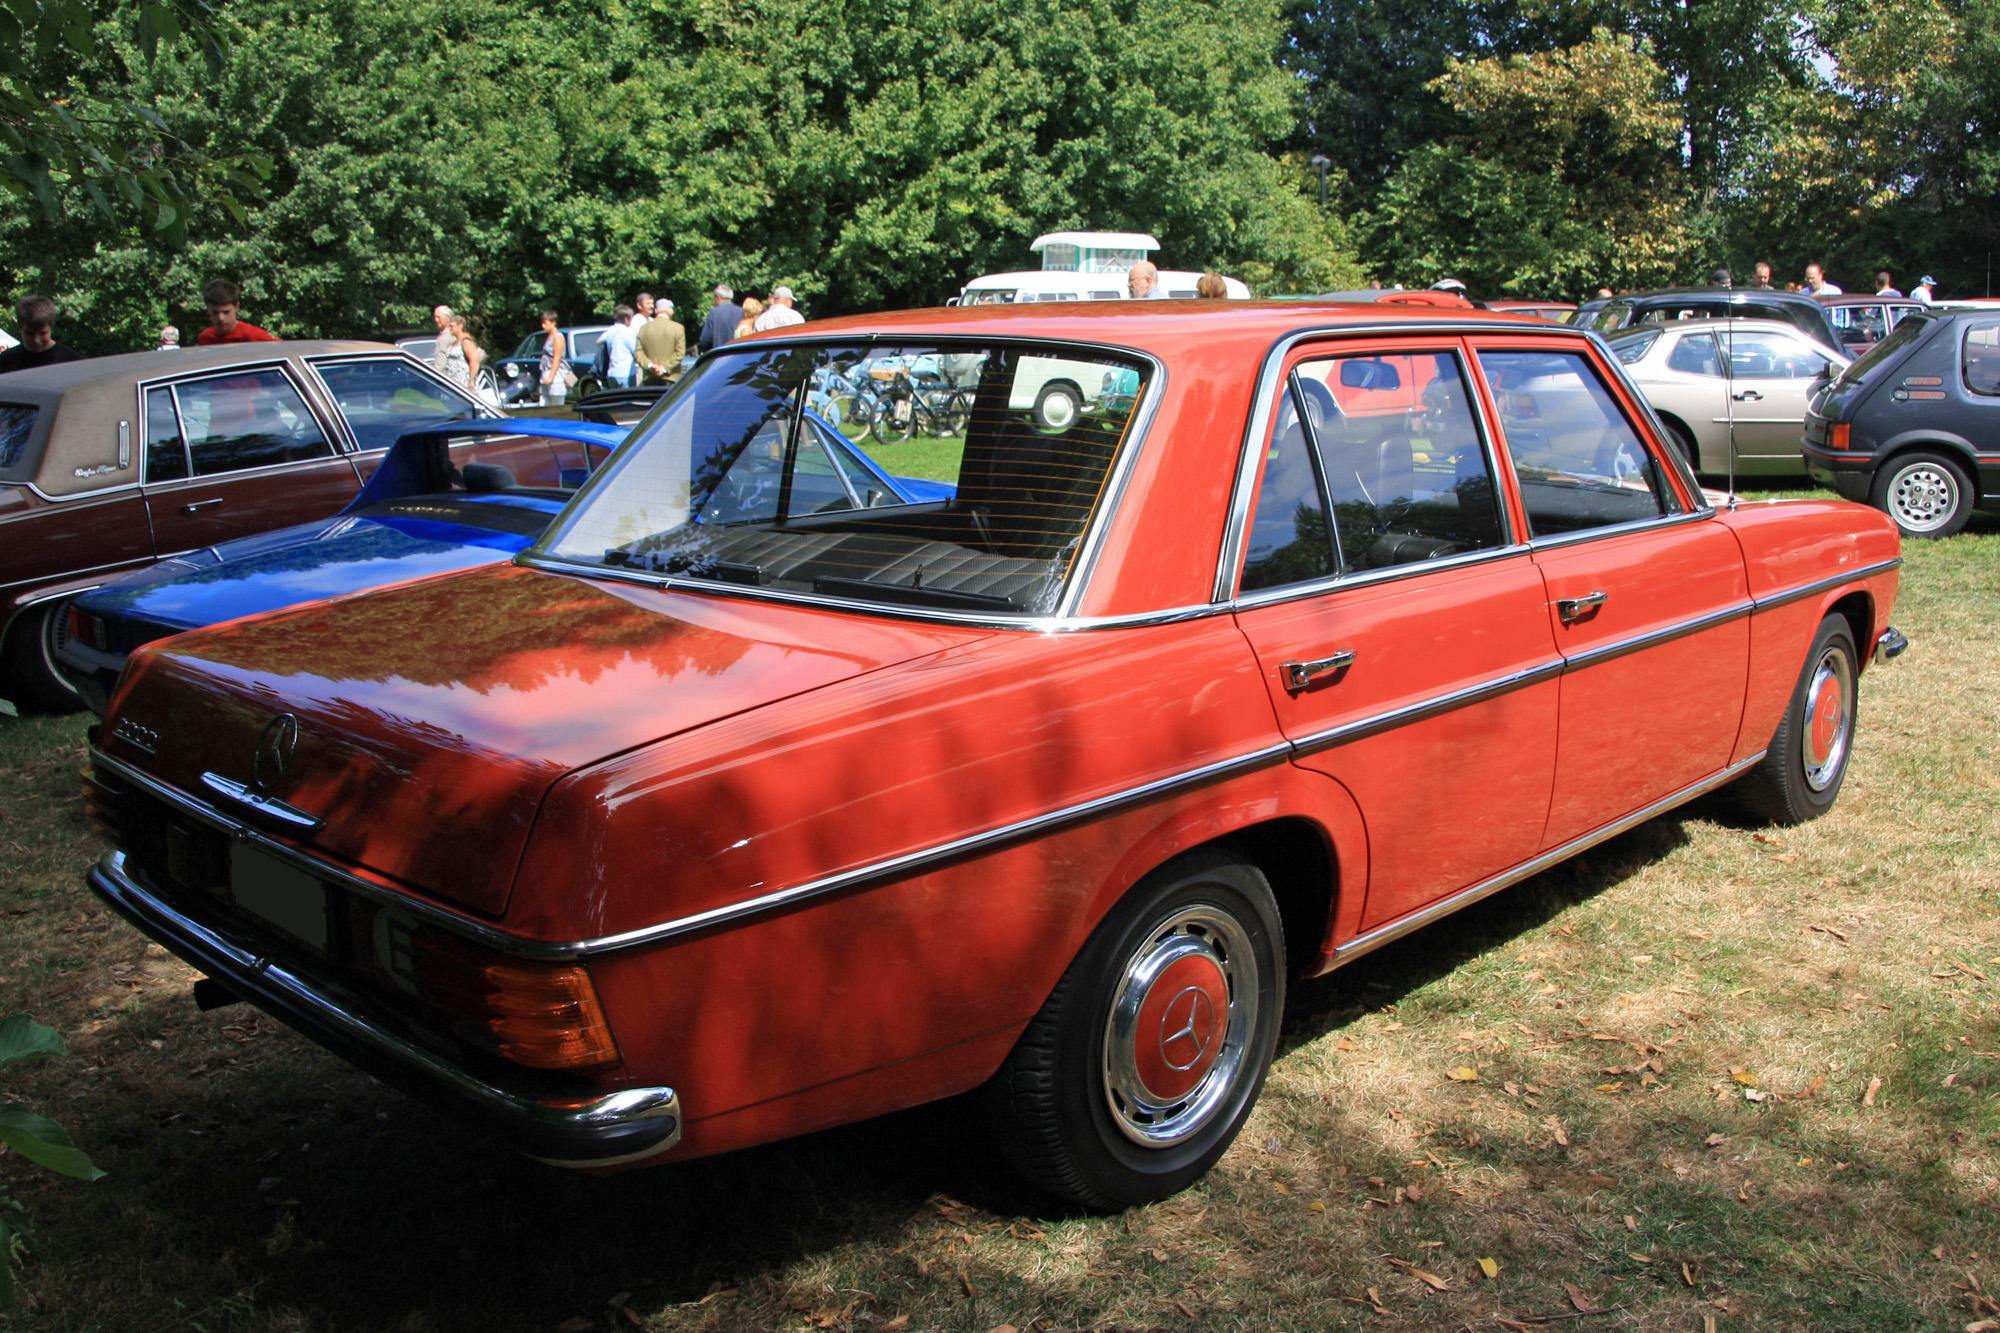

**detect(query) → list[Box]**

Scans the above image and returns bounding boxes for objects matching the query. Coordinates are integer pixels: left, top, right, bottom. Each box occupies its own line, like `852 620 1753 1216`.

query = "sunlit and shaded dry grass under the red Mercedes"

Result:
0 490 2000 1333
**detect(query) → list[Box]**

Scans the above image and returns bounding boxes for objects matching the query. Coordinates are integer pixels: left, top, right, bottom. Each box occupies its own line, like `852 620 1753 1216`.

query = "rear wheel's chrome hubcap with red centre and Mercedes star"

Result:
1104 907 1258 1147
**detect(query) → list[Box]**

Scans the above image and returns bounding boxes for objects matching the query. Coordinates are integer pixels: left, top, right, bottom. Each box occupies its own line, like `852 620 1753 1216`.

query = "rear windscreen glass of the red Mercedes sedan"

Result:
532 344 1150 614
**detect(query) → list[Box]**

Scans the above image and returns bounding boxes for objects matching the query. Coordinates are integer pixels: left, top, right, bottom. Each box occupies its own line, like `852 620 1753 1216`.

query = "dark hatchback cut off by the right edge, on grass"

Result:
1802 310 2000 536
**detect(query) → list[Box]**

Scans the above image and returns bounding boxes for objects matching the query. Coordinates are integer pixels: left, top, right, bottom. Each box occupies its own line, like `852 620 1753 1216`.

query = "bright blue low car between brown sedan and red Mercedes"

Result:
58 412 954 717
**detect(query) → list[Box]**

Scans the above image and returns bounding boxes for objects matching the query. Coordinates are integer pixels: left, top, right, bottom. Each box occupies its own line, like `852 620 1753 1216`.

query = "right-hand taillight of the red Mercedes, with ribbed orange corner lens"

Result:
414 929 622 1069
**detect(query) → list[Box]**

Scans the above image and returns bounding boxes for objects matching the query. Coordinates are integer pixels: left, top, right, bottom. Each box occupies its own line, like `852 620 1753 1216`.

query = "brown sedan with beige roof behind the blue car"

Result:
0 342 584 711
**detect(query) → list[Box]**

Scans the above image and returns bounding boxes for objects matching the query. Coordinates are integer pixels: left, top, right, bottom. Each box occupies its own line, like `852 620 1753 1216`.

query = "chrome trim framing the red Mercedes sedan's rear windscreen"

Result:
512 332 1188 630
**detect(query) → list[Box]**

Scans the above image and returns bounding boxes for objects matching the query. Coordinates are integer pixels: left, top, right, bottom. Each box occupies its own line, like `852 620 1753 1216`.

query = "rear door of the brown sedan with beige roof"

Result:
142 362 360 556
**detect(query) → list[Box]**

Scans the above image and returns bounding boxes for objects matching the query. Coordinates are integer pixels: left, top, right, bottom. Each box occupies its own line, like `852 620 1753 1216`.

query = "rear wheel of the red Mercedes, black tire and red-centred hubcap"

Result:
984 853 1284 1209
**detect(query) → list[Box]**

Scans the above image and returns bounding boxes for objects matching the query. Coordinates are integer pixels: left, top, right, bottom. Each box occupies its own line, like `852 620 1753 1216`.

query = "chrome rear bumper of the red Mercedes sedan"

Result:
90 853 680 1167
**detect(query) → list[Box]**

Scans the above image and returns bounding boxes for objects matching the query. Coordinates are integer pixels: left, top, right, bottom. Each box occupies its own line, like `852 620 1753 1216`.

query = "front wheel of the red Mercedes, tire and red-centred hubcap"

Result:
1736 614 1860 825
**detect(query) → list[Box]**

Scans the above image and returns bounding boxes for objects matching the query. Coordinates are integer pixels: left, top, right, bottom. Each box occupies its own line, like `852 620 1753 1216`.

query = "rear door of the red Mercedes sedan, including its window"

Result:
1236 340 1558 931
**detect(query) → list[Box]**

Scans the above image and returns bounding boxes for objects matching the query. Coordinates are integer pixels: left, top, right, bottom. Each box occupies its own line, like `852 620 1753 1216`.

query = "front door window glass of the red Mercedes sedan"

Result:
1480 350 1680 536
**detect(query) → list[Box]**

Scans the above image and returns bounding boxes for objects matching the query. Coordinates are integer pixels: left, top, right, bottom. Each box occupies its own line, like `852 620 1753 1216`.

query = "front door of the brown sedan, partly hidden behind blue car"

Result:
310 356 590 486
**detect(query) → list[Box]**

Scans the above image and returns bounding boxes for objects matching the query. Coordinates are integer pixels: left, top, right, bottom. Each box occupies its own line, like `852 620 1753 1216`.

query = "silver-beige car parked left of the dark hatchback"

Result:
1608 320 1848 476
